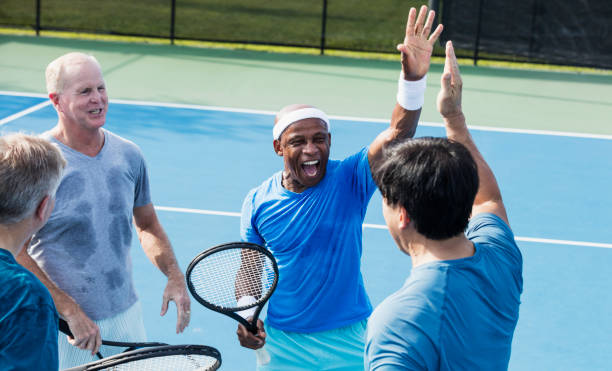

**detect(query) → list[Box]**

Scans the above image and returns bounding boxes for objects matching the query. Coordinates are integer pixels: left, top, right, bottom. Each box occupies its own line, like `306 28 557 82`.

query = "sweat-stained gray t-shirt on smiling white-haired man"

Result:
28 130 151 320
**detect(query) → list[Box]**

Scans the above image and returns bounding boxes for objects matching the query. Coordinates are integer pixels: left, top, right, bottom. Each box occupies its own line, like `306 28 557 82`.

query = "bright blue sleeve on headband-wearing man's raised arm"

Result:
340 147 376 217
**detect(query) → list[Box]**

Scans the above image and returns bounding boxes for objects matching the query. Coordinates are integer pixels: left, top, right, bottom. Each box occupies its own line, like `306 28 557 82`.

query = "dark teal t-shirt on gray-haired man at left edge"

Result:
0 249 58 371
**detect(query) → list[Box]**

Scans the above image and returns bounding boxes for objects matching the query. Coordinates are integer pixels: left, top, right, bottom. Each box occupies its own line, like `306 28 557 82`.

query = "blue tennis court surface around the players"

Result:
0 94 612 370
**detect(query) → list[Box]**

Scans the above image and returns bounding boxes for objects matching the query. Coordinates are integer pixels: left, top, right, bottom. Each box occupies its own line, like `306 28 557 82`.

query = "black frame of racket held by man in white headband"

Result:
185 242 278 334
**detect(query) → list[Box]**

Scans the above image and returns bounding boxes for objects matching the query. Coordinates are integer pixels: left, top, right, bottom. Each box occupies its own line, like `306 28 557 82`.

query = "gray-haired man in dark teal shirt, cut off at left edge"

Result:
0 134 66 371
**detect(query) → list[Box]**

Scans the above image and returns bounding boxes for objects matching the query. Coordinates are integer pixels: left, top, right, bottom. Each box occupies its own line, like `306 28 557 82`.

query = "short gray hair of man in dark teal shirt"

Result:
0 134 66 224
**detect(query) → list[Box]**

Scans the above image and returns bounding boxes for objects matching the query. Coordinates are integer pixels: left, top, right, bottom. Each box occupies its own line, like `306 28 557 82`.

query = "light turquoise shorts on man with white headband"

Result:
257 320 367 371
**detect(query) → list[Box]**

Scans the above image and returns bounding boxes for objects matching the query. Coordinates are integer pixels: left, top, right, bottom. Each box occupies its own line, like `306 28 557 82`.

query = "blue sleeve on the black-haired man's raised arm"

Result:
466 213 523 266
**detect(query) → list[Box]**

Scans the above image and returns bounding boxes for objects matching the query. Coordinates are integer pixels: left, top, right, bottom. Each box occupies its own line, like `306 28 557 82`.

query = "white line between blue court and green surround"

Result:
0 90 612 140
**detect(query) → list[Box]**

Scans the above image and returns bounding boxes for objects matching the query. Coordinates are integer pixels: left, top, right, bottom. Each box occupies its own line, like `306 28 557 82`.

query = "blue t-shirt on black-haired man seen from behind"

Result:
365 214 523 371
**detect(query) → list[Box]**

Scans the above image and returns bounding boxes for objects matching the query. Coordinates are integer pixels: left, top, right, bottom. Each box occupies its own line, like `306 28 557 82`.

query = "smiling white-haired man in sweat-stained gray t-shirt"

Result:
19 53 190 368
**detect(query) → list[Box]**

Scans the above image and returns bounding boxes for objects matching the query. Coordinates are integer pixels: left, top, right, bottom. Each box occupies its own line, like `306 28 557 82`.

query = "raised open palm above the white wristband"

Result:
397 5 443 81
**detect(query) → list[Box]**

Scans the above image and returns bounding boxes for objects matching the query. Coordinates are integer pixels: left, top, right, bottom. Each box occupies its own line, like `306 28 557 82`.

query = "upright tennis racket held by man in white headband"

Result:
186 242 278 365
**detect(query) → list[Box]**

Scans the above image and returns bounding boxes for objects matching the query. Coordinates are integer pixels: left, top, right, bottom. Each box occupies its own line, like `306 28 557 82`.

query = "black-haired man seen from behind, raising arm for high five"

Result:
365 42 523 371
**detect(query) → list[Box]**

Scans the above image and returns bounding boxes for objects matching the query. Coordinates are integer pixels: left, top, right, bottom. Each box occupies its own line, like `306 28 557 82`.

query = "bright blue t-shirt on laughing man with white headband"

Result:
240 148 376 332
